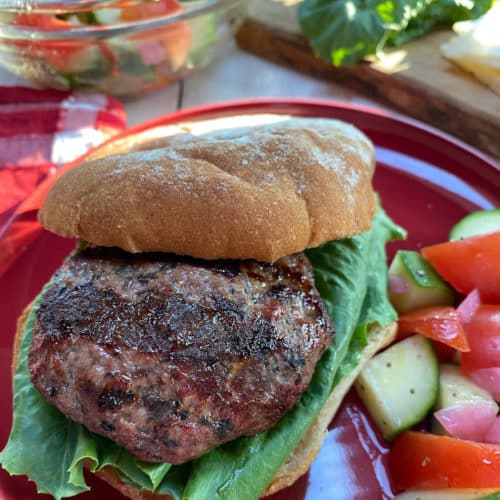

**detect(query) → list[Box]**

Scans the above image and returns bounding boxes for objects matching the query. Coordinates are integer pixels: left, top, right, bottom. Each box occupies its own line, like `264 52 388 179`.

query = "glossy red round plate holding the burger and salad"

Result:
0 100 500 500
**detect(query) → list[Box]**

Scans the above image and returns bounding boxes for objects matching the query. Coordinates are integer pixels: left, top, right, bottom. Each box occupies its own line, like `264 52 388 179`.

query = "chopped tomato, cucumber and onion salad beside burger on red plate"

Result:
355 210 500 499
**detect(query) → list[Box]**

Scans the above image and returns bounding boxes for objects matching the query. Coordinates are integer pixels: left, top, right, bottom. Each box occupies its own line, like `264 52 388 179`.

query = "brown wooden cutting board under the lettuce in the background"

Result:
236 0 500 158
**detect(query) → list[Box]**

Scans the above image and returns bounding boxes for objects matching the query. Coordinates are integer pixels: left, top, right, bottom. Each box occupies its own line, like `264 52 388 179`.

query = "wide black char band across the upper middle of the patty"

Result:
39 283 288 364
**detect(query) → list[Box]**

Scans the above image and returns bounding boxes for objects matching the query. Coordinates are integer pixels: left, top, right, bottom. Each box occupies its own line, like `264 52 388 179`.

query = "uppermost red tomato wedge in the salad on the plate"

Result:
421 232 500 304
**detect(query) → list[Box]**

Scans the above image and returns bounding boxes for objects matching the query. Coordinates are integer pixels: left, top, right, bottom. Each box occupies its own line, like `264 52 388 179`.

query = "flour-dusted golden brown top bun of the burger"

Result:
39 117 375 262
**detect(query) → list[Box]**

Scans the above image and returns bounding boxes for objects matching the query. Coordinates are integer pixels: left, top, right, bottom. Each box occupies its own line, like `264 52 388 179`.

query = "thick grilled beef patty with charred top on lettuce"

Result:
29 247 333 464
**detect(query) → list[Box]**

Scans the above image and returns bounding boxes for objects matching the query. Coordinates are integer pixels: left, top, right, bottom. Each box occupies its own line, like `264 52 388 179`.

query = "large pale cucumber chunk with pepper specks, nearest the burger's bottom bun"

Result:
354 335 439 441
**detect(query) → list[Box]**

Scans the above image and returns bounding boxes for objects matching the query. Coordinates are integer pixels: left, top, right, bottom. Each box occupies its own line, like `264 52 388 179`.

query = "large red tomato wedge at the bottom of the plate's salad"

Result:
389 431 500 490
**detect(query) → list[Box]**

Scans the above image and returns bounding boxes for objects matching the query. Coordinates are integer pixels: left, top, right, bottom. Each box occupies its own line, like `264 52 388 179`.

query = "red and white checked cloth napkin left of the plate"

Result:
0 87 126 275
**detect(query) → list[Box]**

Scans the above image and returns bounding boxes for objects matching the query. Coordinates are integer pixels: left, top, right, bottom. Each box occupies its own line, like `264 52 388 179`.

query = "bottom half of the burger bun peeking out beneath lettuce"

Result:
12 304 397 500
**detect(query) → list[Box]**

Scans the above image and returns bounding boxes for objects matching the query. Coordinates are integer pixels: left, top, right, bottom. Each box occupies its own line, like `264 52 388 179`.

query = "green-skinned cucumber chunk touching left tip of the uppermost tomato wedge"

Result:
389 250 455 314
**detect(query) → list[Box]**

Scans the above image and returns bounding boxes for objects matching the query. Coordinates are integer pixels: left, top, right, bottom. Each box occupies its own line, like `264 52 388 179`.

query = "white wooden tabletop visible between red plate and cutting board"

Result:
0 37 375 126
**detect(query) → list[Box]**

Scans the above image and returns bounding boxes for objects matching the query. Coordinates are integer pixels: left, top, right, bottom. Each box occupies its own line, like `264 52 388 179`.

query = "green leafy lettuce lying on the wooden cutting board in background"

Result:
297 0 493 66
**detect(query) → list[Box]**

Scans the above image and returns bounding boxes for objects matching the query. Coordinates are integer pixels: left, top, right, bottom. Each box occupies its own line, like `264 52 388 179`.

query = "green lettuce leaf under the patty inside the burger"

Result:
0 204 404 500
